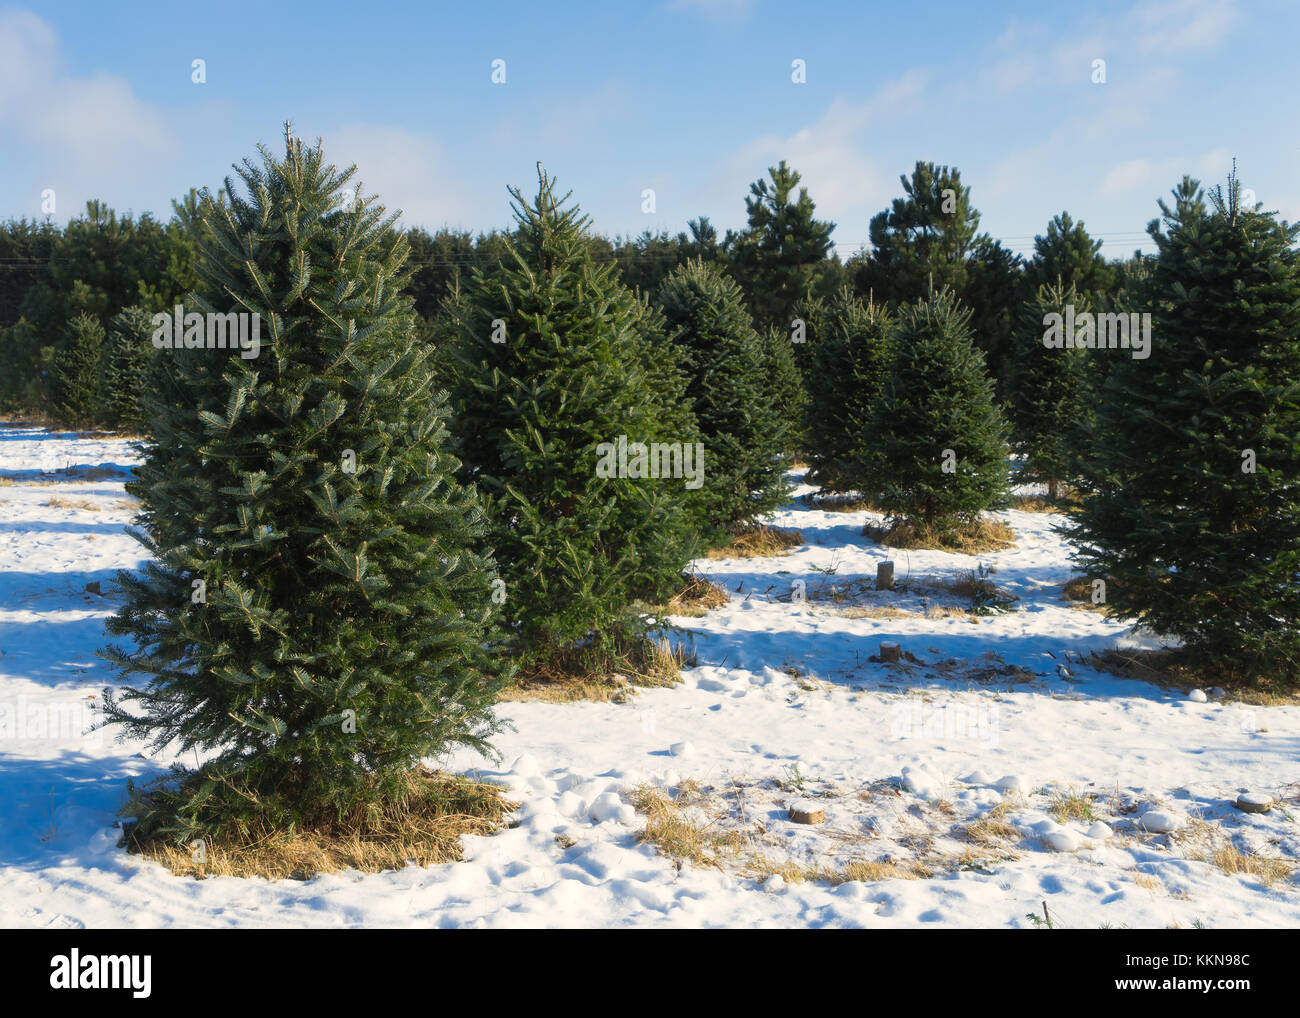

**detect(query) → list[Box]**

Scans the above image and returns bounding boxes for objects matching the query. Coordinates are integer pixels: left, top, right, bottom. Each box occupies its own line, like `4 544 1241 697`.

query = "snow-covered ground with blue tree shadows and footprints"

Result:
0 425 1300 928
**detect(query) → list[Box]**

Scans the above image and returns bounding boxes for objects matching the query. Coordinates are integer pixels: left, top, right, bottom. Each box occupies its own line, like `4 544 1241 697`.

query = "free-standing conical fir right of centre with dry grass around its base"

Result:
846 291 1008 533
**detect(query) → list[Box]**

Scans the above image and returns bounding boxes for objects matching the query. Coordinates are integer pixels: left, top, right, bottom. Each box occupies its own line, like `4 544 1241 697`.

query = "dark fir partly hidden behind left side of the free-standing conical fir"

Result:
807 287 893 491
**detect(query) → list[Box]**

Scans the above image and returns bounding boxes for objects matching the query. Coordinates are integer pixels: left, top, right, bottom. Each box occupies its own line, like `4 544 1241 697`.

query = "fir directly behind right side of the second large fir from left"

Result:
657 261 787 537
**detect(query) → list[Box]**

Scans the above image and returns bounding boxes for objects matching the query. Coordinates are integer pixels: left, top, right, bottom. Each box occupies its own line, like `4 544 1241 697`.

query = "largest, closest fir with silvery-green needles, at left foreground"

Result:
104 127 497 841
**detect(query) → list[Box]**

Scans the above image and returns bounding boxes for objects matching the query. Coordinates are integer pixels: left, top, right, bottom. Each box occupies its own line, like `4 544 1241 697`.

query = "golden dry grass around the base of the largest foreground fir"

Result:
127 767 517 880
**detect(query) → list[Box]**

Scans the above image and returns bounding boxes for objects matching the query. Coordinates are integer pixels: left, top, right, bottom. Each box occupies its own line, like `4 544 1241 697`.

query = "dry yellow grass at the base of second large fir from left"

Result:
498 638 689 703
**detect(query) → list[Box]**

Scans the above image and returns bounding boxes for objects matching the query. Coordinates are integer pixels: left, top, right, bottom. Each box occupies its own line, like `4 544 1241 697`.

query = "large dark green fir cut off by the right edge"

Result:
1069 173 1300 684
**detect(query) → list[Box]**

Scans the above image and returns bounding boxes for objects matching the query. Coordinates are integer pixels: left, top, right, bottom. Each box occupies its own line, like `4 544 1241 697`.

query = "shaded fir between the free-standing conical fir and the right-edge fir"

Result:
1008 285 1093 499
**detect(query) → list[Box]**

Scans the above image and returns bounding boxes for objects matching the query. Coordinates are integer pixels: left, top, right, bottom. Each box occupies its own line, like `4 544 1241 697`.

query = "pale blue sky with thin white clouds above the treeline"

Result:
0 0 1300 256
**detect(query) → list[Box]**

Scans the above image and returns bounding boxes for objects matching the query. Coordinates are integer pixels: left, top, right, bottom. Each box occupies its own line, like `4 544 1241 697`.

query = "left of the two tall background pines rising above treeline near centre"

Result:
729 160 835 329
